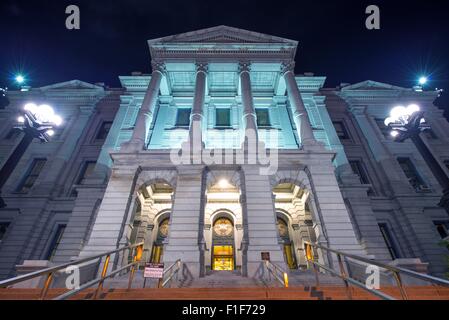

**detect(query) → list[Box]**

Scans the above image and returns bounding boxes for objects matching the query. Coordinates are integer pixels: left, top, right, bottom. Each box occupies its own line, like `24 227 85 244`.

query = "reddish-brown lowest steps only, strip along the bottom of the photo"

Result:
0 286 449 300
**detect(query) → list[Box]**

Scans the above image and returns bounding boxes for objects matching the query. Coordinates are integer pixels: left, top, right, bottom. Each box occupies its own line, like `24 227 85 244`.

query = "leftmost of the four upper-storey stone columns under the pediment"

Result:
122 62 165 151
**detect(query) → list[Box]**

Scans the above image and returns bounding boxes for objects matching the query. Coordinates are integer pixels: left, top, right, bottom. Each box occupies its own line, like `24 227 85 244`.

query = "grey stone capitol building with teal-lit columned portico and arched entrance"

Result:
0 26 449 292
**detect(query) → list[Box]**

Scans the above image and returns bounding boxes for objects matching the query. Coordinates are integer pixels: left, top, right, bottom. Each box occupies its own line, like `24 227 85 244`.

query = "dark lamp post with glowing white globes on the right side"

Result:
385 104 449 214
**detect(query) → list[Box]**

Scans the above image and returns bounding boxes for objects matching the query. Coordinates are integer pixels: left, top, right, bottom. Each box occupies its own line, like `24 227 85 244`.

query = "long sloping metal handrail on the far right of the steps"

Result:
304 241 449 300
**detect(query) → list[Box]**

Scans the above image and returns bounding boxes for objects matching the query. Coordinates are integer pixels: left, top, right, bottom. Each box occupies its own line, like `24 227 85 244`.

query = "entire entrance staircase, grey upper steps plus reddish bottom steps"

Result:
0 264 449 300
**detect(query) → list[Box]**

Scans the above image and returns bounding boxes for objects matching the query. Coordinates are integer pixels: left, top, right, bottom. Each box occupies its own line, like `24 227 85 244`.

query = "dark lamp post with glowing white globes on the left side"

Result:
0 103 62 208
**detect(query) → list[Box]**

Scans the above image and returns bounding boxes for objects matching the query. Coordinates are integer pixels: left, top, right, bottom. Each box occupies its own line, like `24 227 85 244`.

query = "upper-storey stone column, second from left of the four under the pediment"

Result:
189 63 207 151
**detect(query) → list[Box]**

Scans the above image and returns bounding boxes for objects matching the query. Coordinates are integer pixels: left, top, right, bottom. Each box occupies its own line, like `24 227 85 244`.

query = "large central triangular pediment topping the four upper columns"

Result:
148 26 297 46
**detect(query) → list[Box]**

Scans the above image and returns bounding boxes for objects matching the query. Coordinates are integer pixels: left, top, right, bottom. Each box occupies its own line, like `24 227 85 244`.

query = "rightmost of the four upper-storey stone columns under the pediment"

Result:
282 62 316 145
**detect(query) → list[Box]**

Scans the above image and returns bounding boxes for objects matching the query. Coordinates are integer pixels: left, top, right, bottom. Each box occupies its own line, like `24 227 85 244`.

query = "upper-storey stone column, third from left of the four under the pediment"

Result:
239 62 258 145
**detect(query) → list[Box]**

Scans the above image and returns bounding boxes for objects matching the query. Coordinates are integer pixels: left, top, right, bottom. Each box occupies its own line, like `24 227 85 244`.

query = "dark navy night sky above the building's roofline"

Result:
0 0 449 113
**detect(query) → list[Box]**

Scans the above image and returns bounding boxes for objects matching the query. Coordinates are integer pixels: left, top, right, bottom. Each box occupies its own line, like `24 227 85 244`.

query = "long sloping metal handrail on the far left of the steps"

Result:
0 242 143 300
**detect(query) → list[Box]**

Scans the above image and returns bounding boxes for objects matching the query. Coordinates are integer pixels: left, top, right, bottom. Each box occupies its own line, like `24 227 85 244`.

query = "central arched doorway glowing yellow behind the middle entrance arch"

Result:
212 217 235 270
